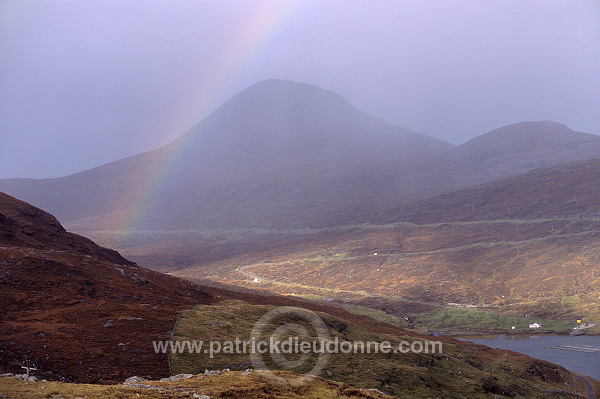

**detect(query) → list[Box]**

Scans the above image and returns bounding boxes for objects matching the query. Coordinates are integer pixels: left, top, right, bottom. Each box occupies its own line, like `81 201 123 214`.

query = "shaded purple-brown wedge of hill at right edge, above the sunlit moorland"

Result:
374 158 600 223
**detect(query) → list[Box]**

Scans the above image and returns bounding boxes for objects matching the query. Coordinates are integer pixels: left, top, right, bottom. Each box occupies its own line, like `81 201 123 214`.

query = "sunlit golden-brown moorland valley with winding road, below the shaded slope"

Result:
81 219 600 332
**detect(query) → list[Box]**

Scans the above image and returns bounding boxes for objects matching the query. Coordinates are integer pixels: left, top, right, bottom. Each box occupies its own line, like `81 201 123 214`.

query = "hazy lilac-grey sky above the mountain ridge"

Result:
0 0 600 177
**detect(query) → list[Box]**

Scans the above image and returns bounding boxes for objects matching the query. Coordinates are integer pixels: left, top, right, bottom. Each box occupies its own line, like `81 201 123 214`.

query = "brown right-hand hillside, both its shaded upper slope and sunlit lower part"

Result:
149 159 600 321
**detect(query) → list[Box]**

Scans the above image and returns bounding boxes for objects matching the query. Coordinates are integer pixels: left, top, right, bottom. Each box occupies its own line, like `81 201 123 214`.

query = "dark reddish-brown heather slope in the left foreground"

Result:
0 193 214 382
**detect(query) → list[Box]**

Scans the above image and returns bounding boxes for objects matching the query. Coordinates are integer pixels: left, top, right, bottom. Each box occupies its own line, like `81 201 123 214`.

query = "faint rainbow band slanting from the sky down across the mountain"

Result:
111 0 301 242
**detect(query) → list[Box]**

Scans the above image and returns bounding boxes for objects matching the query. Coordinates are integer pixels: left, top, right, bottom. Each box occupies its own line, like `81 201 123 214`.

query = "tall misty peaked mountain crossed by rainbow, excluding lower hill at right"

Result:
0 80 452 229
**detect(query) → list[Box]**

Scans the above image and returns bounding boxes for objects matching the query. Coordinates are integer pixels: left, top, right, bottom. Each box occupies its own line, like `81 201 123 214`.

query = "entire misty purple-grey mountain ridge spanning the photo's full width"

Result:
0 80 600 230
